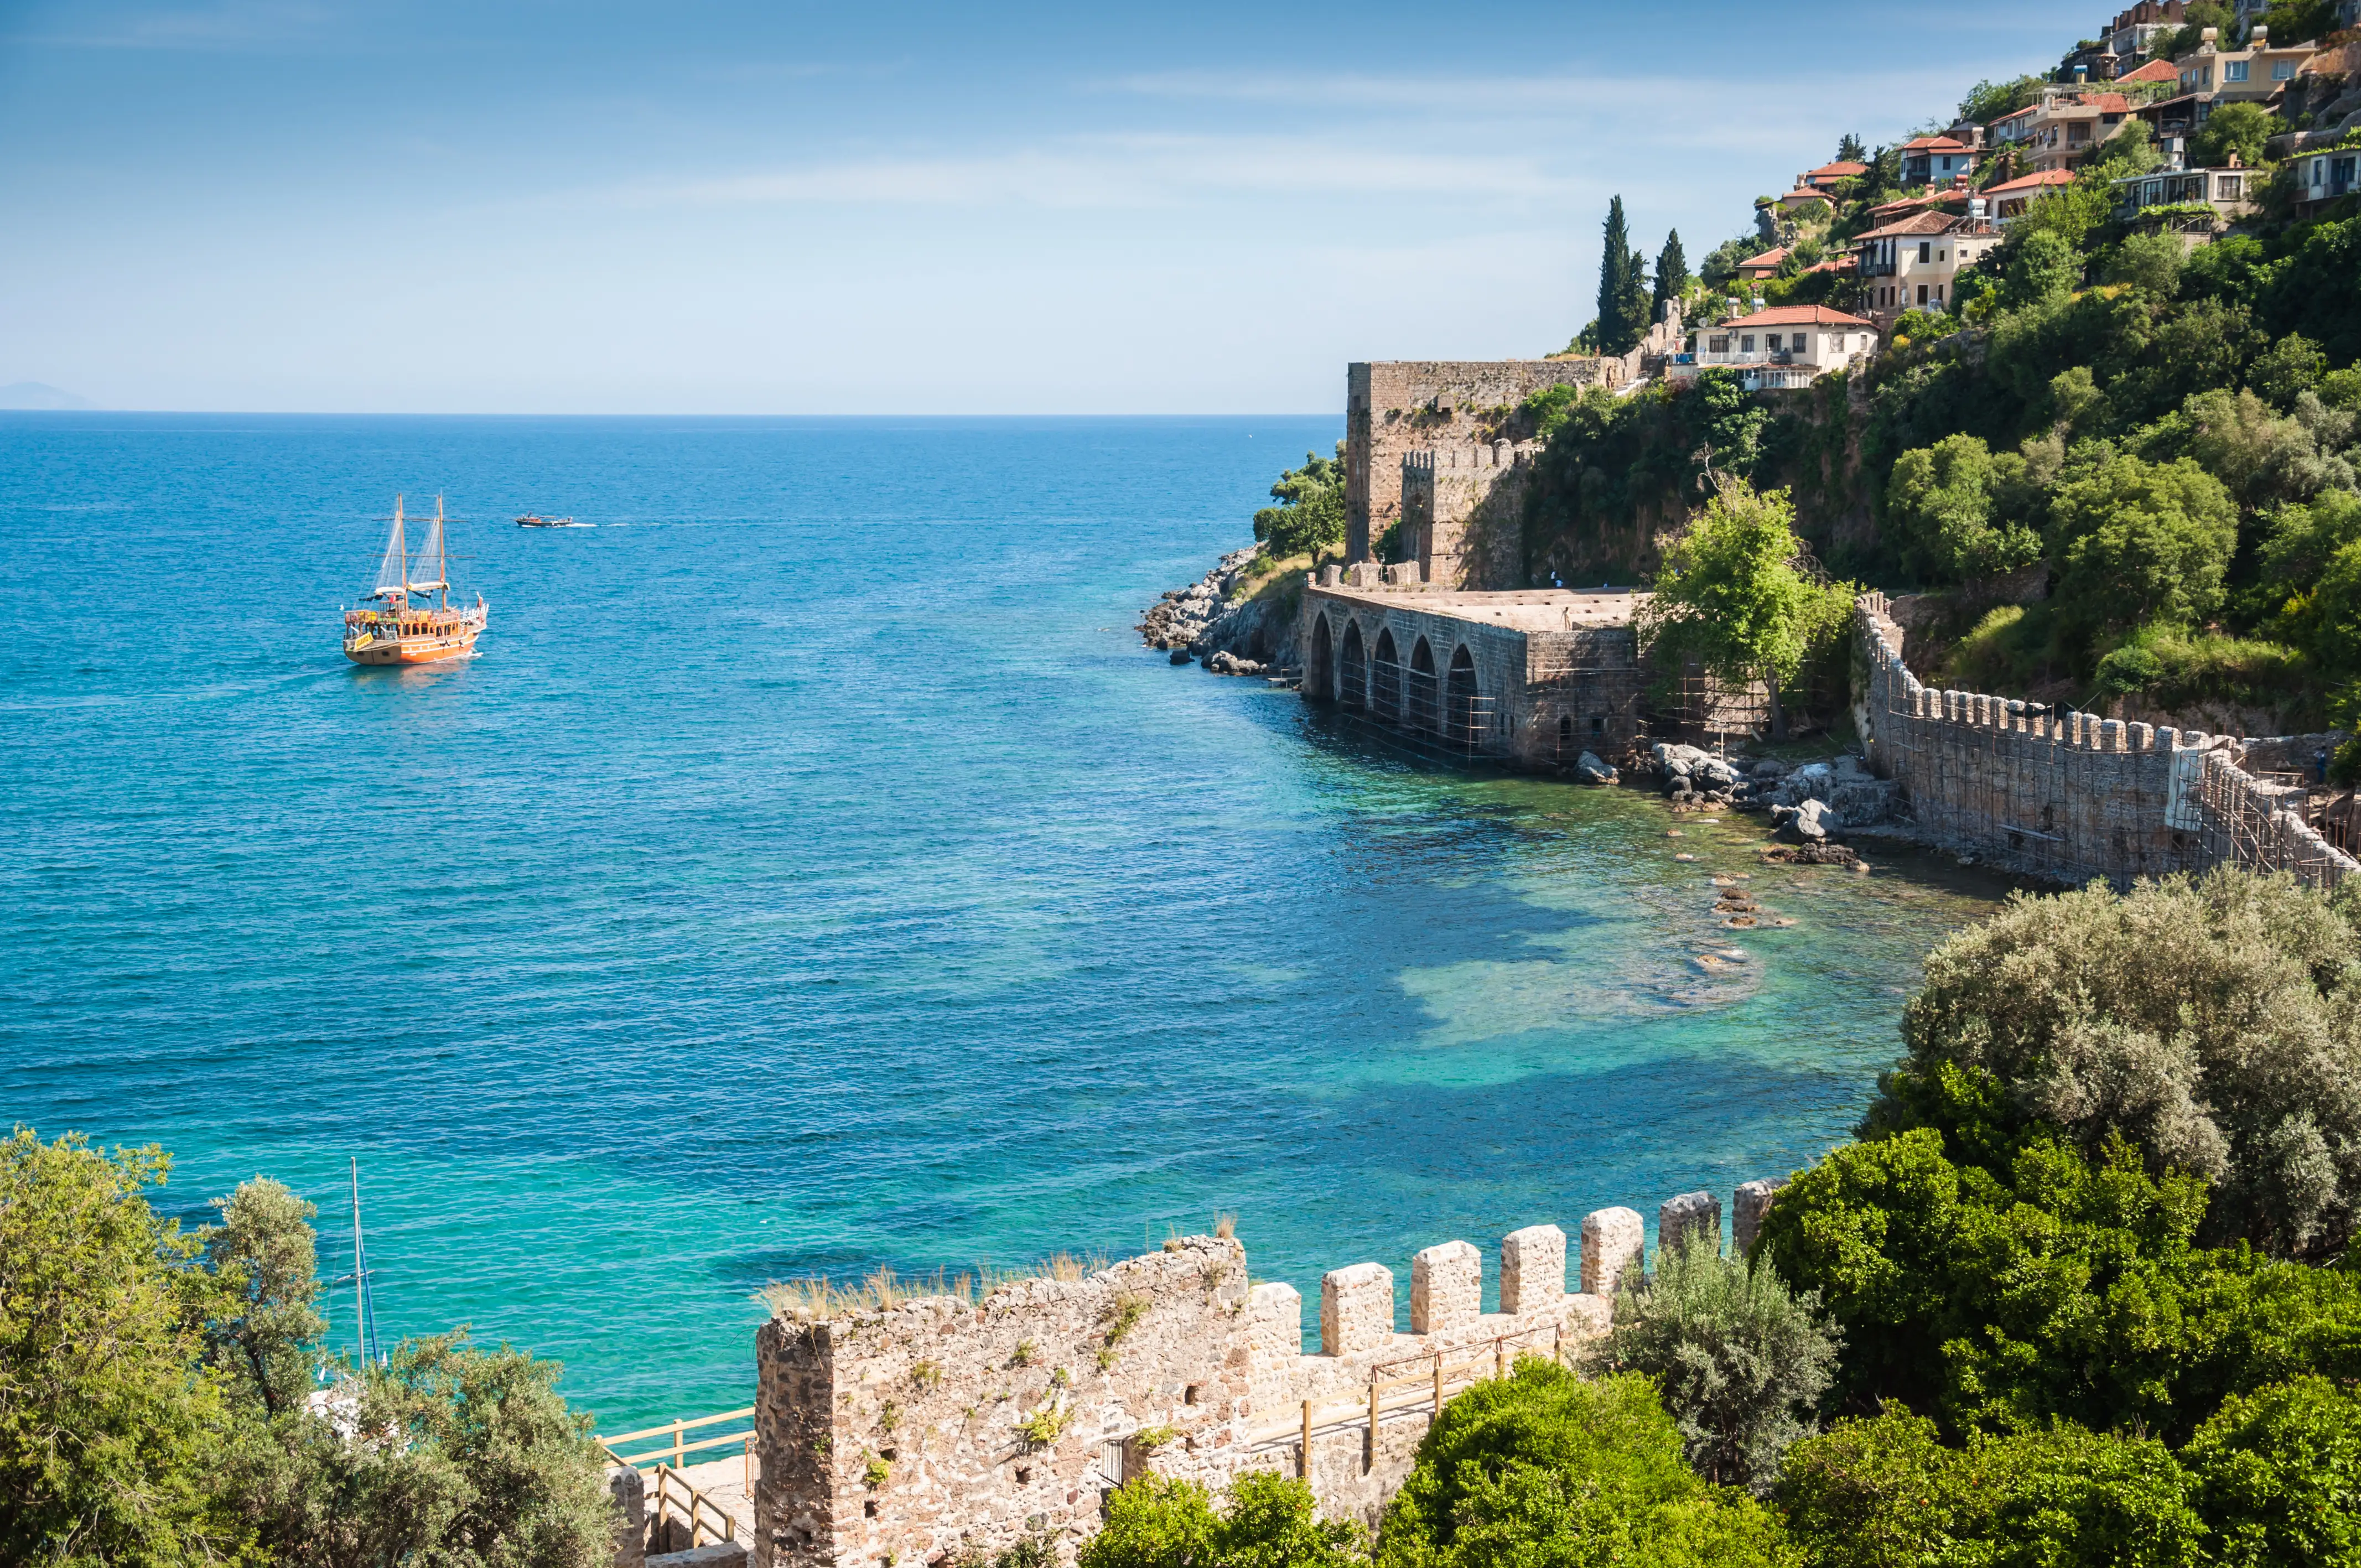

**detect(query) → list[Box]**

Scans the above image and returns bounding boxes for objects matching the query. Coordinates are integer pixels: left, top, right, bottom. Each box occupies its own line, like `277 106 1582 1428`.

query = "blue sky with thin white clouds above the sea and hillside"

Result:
0 0 2068 413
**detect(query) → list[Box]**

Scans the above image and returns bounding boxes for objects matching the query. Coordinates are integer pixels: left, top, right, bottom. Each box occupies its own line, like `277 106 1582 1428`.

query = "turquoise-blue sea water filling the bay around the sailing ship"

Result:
0 416 1995 1431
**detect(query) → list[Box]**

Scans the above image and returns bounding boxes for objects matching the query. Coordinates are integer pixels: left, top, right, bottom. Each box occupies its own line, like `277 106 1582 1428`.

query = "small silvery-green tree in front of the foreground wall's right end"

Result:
1594 1235 1839 1492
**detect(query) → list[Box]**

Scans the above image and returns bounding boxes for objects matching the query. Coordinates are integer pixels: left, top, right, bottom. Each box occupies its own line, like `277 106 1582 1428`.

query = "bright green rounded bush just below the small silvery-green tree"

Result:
1377 1356 1797 1568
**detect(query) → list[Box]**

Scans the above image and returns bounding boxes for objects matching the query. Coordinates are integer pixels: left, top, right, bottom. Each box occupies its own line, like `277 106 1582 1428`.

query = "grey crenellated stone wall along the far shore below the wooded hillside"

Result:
1854 593 2356 886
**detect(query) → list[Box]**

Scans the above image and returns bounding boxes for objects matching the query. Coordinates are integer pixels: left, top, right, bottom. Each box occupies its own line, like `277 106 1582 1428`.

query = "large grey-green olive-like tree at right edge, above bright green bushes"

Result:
1879 869 2361 1283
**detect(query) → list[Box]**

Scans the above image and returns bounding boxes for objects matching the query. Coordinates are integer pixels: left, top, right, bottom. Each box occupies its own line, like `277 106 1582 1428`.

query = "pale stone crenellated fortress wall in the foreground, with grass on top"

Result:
753 1181 1776 1568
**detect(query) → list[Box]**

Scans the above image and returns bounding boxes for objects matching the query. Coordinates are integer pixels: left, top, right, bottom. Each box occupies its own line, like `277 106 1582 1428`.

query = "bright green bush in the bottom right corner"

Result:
2182 1377 2361 1568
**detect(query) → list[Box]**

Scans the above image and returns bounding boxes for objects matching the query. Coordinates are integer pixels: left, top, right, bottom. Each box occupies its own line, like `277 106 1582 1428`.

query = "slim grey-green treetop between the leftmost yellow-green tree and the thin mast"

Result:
201 1176 328 1417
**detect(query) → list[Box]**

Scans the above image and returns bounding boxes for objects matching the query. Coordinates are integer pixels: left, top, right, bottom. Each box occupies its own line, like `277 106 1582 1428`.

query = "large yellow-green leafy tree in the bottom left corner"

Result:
0 1126 250 1568
